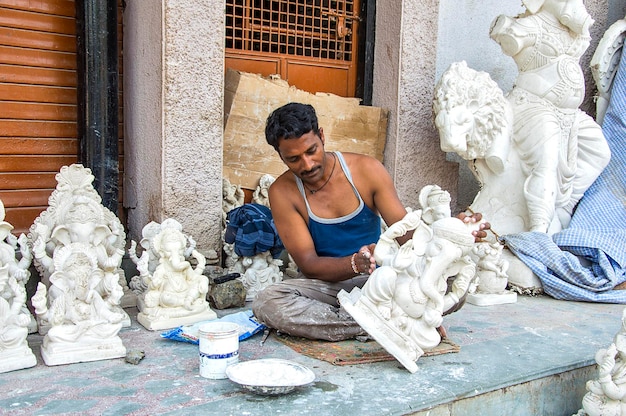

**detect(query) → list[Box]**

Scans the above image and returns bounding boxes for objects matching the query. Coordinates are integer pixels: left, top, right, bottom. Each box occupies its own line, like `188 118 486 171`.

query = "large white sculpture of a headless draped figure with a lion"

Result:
434 0 610 235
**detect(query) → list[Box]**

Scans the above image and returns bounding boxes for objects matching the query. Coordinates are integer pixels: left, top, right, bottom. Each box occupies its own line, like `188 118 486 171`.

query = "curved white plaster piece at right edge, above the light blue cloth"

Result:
589 18 626 125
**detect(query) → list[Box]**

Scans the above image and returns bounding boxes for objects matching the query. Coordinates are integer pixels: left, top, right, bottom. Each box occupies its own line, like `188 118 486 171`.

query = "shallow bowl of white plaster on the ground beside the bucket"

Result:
226 358 315 396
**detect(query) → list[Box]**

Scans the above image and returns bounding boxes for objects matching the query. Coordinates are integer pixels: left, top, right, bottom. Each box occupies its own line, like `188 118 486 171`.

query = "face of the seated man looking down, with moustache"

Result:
278 129 325 183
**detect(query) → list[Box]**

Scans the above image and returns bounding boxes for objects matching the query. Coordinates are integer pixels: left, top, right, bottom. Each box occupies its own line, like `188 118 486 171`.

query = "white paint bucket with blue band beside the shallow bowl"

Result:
198 322 239 379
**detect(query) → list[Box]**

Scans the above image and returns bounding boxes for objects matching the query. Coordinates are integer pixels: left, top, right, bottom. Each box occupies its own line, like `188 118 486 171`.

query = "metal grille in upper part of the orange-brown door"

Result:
226 0 358 61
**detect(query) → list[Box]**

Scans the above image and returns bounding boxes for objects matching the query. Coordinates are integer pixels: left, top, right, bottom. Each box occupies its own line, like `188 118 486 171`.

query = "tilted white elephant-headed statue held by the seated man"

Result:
338 210 476 372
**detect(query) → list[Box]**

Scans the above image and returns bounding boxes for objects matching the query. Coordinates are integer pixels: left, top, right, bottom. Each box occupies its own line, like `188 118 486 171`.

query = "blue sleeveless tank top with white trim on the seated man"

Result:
294 152 381 257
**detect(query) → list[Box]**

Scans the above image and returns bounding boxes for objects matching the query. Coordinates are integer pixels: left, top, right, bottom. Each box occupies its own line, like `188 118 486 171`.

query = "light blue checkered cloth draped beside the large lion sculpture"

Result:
502 48 626 303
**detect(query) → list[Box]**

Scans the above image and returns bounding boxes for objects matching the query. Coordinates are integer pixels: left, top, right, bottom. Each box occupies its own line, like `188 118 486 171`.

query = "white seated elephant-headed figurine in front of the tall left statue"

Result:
31 242 127 366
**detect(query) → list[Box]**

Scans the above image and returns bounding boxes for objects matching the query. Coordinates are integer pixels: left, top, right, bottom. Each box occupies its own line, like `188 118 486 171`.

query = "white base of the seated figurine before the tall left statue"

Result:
41 336 126 366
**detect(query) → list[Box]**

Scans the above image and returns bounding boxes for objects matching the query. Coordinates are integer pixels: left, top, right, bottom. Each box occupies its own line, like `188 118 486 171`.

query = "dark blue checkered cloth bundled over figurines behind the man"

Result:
224 204 284 258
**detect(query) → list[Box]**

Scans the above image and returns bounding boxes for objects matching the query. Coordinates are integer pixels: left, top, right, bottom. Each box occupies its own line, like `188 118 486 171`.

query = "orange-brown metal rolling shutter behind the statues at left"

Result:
0 0 123 235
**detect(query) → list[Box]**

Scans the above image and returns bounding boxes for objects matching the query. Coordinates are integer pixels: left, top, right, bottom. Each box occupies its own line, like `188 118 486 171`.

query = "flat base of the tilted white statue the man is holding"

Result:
337 287 424 373
